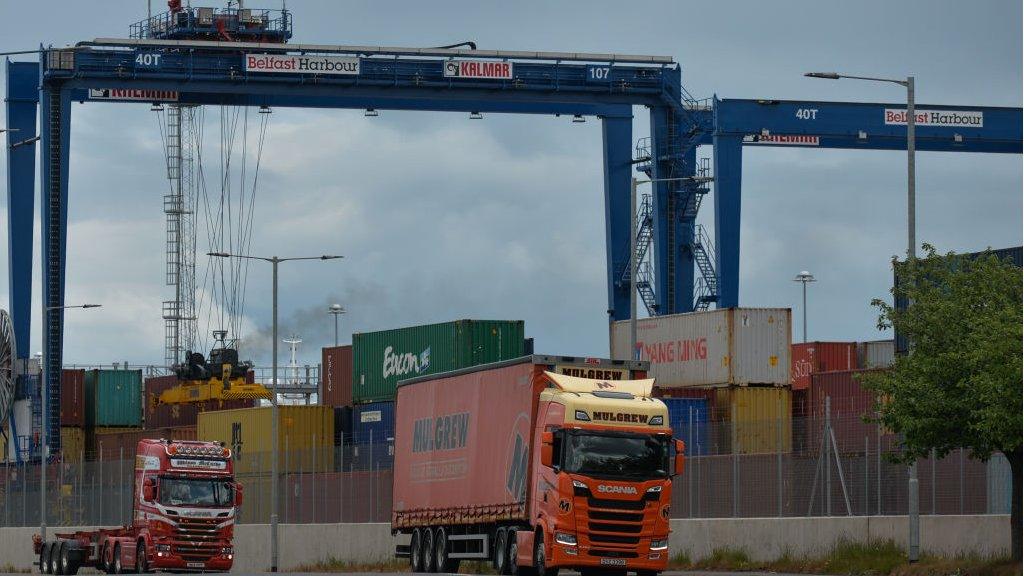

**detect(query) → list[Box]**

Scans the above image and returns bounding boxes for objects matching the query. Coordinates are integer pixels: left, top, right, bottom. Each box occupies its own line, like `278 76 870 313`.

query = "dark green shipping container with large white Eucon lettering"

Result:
352 320 525 404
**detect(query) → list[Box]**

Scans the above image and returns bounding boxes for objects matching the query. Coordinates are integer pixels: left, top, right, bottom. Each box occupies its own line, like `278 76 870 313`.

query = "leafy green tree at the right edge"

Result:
863 244 1024 561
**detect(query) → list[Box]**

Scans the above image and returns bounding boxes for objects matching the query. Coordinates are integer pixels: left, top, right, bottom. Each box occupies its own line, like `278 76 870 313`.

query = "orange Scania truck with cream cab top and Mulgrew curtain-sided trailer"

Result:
391 356 684 576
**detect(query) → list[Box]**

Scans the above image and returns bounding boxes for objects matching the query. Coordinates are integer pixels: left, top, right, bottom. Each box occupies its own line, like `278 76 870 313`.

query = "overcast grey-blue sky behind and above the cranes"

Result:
0 0 1022 364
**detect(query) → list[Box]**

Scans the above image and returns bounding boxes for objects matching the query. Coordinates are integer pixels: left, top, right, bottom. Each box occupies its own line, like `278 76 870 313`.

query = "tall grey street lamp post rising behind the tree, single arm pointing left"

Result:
804 72 921 562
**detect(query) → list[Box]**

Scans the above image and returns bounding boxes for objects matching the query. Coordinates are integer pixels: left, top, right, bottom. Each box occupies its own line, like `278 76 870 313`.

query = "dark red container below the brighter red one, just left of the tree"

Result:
807 370 888 453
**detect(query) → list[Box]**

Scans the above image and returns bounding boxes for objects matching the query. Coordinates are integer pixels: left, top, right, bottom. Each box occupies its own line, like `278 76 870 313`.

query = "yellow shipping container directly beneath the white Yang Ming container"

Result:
715 386 793 454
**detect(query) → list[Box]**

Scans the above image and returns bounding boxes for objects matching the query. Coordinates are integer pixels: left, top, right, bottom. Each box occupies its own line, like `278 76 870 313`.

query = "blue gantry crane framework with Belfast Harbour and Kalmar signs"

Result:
6 3 1022 452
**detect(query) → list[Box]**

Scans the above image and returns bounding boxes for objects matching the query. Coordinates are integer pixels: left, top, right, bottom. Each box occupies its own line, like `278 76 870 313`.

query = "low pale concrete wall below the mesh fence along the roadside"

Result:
0 516 1010 572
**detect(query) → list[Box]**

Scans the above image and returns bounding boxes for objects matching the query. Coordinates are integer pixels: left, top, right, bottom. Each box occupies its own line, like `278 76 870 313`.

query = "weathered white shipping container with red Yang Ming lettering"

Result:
611 307 793 388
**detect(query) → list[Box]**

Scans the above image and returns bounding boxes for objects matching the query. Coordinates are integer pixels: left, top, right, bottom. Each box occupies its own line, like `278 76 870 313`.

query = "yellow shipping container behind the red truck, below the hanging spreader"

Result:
197 406 334 475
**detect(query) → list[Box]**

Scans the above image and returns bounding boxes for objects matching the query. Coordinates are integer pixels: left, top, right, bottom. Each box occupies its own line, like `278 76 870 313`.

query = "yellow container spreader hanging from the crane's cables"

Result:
156 331 270 404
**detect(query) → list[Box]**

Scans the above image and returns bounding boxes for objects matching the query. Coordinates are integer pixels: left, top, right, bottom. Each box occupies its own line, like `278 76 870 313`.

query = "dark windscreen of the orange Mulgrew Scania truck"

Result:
563 431 669 479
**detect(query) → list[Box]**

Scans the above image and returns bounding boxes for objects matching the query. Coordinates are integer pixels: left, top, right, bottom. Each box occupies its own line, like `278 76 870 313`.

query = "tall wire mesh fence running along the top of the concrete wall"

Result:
0 409 1012 526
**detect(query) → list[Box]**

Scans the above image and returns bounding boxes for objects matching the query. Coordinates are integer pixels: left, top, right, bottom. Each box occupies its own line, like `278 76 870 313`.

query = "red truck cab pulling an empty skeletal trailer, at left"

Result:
33 440 242 574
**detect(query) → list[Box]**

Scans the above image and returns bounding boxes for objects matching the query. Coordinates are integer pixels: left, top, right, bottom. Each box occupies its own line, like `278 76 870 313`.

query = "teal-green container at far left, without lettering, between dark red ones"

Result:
85 370 142 427
